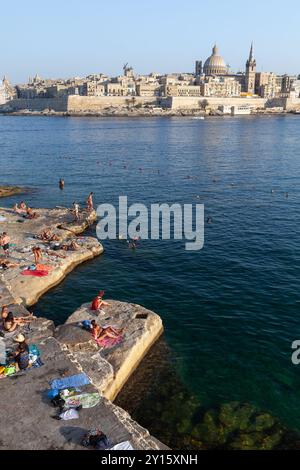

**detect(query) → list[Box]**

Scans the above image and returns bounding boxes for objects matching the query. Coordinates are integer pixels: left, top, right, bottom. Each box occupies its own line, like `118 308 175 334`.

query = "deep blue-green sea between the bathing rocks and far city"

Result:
0 116 300 430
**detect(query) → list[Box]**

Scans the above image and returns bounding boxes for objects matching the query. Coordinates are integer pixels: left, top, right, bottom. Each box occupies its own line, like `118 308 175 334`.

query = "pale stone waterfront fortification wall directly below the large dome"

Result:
168 96 267 109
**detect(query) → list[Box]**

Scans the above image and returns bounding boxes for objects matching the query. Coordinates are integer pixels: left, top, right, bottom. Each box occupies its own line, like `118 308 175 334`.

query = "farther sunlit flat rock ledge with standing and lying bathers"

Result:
0 208 103 306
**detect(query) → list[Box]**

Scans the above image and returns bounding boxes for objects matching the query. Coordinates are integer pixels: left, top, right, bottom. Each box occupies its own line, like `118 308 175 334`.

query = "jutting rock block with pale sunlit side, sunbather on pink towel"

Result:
55 300 163 400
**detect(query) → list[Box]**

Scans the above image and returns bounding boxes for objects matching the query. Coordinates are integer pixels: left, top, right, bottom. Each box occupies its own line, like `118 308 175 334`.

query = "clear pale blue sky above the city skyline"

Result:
0 0 300 83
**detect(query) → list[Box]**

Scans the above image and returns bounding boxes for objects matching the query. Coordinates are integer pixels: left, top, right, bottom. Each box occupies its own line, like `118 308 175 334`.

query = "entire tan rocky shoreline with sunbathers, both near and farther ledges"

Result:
0 208 167 450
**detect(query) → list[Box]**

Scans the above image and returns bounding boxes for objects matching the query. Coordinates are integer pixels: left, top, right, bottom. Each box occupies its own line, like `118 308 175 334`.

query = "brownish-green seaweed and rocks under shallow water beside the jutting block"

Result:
115 339 300 450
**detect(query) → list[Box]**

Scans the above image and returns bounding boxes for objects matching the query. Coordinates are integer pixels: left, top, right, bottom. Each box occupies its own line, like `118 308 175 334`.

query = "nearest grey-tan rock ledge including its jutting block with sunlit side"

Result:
0 300 167 450
